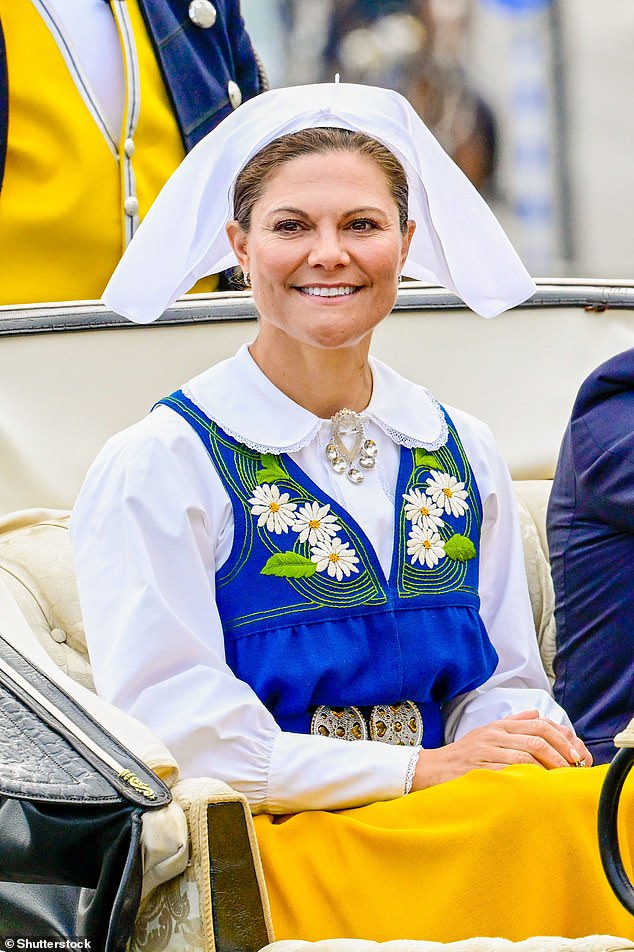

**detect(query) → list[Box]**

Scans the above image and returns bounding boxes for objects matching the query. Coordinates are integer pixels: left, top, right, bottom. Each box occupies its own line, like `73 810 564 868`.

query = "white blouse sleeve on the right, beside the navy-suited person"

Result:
445 410 570 742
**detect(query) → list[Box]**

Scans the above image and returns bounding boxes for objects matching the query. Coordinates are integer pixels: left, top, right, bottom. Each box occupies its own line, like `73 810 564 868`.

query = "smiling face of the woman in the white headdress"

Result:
227 152 414 349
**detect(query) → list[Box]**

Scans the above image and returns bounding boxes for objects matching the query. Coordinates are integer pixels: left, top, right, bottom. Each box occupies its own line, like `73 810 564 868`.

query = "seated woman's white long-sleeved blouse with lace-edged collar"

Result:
71 346 569 813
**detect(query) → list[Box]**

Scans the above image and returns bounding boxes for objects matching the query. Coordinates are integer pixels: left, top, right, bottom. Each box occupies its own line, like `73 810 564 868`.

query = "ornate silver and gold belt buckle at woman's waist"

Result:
310 701 423 747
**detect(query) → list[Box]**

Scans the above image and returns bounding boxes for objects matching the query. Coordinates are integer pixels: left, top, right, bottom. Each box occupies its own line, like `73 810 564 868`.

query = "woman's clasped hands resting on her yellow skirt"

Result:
412 711 592 790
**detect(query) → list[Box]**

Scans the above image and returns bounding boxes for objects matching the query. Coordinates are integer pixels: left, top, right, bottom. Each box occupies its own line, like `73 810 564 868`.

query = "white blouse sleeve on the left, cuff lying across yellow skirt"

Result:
71 407 412 813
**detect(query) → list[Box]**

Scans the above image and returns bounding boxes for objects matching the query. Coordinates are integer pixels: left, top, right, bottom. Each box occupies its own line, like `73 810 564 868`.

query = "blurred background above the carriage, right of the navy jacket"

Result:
242 0 634 280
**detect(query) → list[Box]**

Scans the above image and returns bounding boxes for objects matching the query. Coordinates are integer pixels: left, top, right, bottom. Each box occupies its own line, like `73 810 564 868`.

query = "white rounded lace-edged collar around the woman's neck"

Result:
183 344 447 453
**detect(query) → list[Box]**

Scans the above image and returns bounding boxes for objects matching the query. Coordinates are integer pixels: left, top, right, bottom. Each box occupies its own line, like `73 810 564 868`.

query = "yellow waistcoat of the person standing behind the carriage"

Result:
0 0 216 304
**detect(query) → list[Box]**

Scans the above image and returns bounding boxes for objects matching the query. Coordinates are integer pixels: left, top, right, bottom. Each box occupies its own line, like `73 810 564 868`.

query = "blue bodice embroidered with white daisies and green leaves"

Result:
160 391 498 747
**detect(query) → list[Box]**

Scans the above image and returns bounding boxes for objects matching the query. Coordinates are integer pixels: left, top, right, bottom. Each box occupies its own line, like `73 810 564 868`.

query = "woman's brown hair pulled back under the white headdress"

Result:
233 127 408 234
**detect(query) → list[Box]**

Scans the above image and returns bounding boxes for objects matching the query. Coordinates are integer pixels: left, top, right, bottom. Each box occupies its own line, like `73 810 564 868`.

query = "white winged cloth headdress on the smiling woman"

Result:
103 83 535 324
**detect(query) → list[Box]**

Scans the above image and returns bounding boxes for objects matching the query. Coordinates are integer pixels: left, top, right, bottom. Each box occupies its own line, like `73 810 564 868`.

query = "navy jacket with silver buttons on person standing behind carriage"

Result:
0 0 266 187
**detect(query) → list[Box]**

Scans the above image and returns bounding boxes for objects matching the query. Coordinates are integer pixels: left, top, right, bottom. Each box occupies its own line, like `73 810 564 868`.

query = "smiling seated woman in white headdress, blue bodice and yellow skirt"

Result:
73 84 630 940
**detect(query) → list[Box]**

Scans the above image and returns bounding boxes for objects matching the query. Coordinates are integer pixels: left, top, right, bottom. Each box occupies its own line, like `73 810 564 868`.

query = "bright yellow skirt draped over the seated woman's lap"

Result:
255 767 634 942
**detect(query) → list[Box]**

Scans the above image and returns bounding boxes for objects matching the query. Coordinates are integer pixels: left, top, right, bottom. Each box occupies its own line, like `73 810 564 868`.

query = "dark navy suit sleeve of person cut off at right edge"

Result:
548 349 634 763
